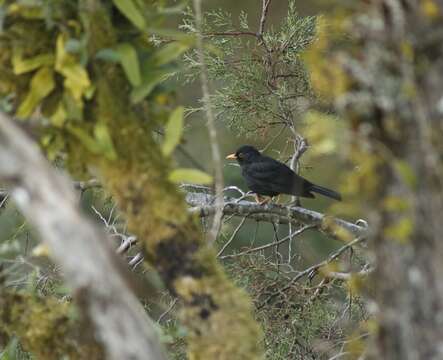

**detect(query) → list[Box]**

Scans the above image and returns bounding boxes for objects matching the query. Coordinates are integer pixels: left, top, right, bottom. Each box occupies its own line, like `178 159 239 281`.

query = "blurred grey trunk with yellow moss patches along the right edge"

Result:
326 0 443 360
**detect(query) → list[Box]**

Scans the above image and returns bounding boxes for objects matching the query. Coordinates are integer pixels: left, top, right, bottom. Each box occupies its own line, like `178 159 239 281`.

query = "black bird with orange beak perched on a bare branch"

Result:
226 145 341 203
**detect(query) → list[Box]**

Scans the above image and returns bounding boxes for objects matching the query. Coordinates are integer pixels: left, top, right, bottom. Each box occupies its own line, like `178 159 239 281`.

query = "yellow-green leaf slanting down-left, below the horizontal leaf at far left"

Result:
17 67 55 118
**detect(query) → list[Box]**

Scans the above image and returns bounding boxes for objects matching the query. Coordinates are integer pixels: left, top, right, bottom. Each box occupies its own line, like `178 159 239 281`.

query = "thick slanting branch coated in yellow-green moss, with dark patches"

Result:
80 2 262 359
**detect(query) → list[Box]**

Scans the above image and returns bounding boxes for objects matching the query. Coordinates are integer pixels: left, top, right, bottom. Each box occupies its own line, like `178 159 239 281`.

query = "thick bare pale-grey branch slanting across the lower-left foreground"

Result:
0 114 166 360
